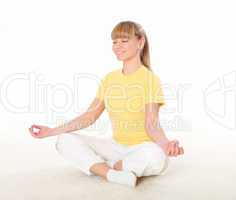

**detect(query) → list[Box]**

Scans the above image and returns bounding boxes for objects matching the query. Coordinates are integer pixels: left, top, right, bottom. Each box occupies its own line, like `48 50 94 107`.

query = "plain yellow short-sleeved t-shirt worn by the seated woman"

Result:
96 65 165 145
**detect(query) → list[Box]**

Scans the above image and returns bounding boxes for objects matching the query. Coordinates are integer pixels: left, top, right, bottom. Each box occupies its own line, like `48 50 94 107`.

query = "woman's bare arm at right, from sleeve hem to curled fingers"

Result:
145 103 184 156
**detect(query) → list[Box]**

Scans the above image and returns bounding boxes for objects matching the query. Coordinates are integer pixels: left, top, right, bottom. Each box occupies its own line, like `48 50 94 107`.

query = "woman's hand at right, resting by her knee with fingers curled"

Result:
158 140 184 157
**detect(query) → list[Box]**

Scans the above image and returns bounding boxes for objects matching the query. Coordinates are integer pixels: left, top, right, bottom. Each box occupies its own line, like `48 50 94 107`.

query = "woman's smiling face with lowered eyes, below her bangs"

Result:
112 37 142 61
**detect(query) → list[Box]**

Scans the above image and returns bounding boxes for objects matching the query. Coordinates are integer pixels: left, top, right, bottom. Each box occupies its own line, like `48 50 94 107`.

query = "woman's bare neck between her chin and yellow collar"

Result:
122 57 142 74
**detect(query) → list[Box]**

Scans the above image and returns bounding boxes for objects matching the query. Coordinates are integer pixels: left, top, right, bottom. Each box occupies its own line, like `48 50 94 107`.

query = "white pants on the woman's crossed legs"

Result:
56 133 169 177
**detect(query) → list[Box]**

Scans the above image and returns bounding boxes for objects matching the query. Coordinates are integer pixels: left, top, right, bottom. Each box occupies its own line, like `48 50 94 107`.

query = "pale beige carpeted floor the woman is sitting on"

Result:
0 130 236 200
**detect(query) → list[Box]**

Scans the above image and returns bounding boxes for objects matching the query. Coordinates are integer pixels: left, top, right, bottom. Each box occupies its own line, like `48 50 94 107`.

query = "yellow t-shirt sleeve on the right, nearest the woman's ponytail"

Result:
145 73 165 106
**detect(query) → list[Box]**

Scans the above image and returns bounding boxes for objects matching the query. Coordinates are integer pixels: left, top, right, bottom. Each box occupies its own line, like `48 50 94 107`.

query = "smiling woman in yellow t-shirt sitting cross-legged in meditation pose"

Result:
29 21 184 186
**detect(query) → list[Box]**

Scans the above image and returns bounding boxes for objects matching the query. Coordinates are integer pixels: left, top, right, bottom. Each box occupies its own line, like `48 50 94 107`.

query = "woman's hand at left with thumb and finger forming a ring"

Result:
29 125 53 138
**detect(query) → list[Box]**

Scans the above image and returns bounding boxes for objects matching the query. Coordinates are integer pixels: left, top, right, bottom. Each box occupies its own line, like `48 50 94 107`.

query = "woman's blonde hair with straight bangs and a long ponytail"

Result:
111 21 152 71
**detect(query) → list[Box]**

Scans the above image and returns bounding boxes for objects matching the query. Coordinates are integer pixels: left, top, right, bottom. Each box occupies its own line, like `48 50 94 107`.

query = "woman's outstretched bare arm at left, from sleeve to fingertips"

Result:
29 98 105 138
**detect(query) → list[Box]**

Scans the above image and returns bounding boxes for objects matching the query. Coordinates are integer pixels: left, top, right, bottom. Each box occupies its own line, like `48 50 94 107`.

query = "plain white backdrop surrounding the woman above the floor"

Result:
0 0 236 199
